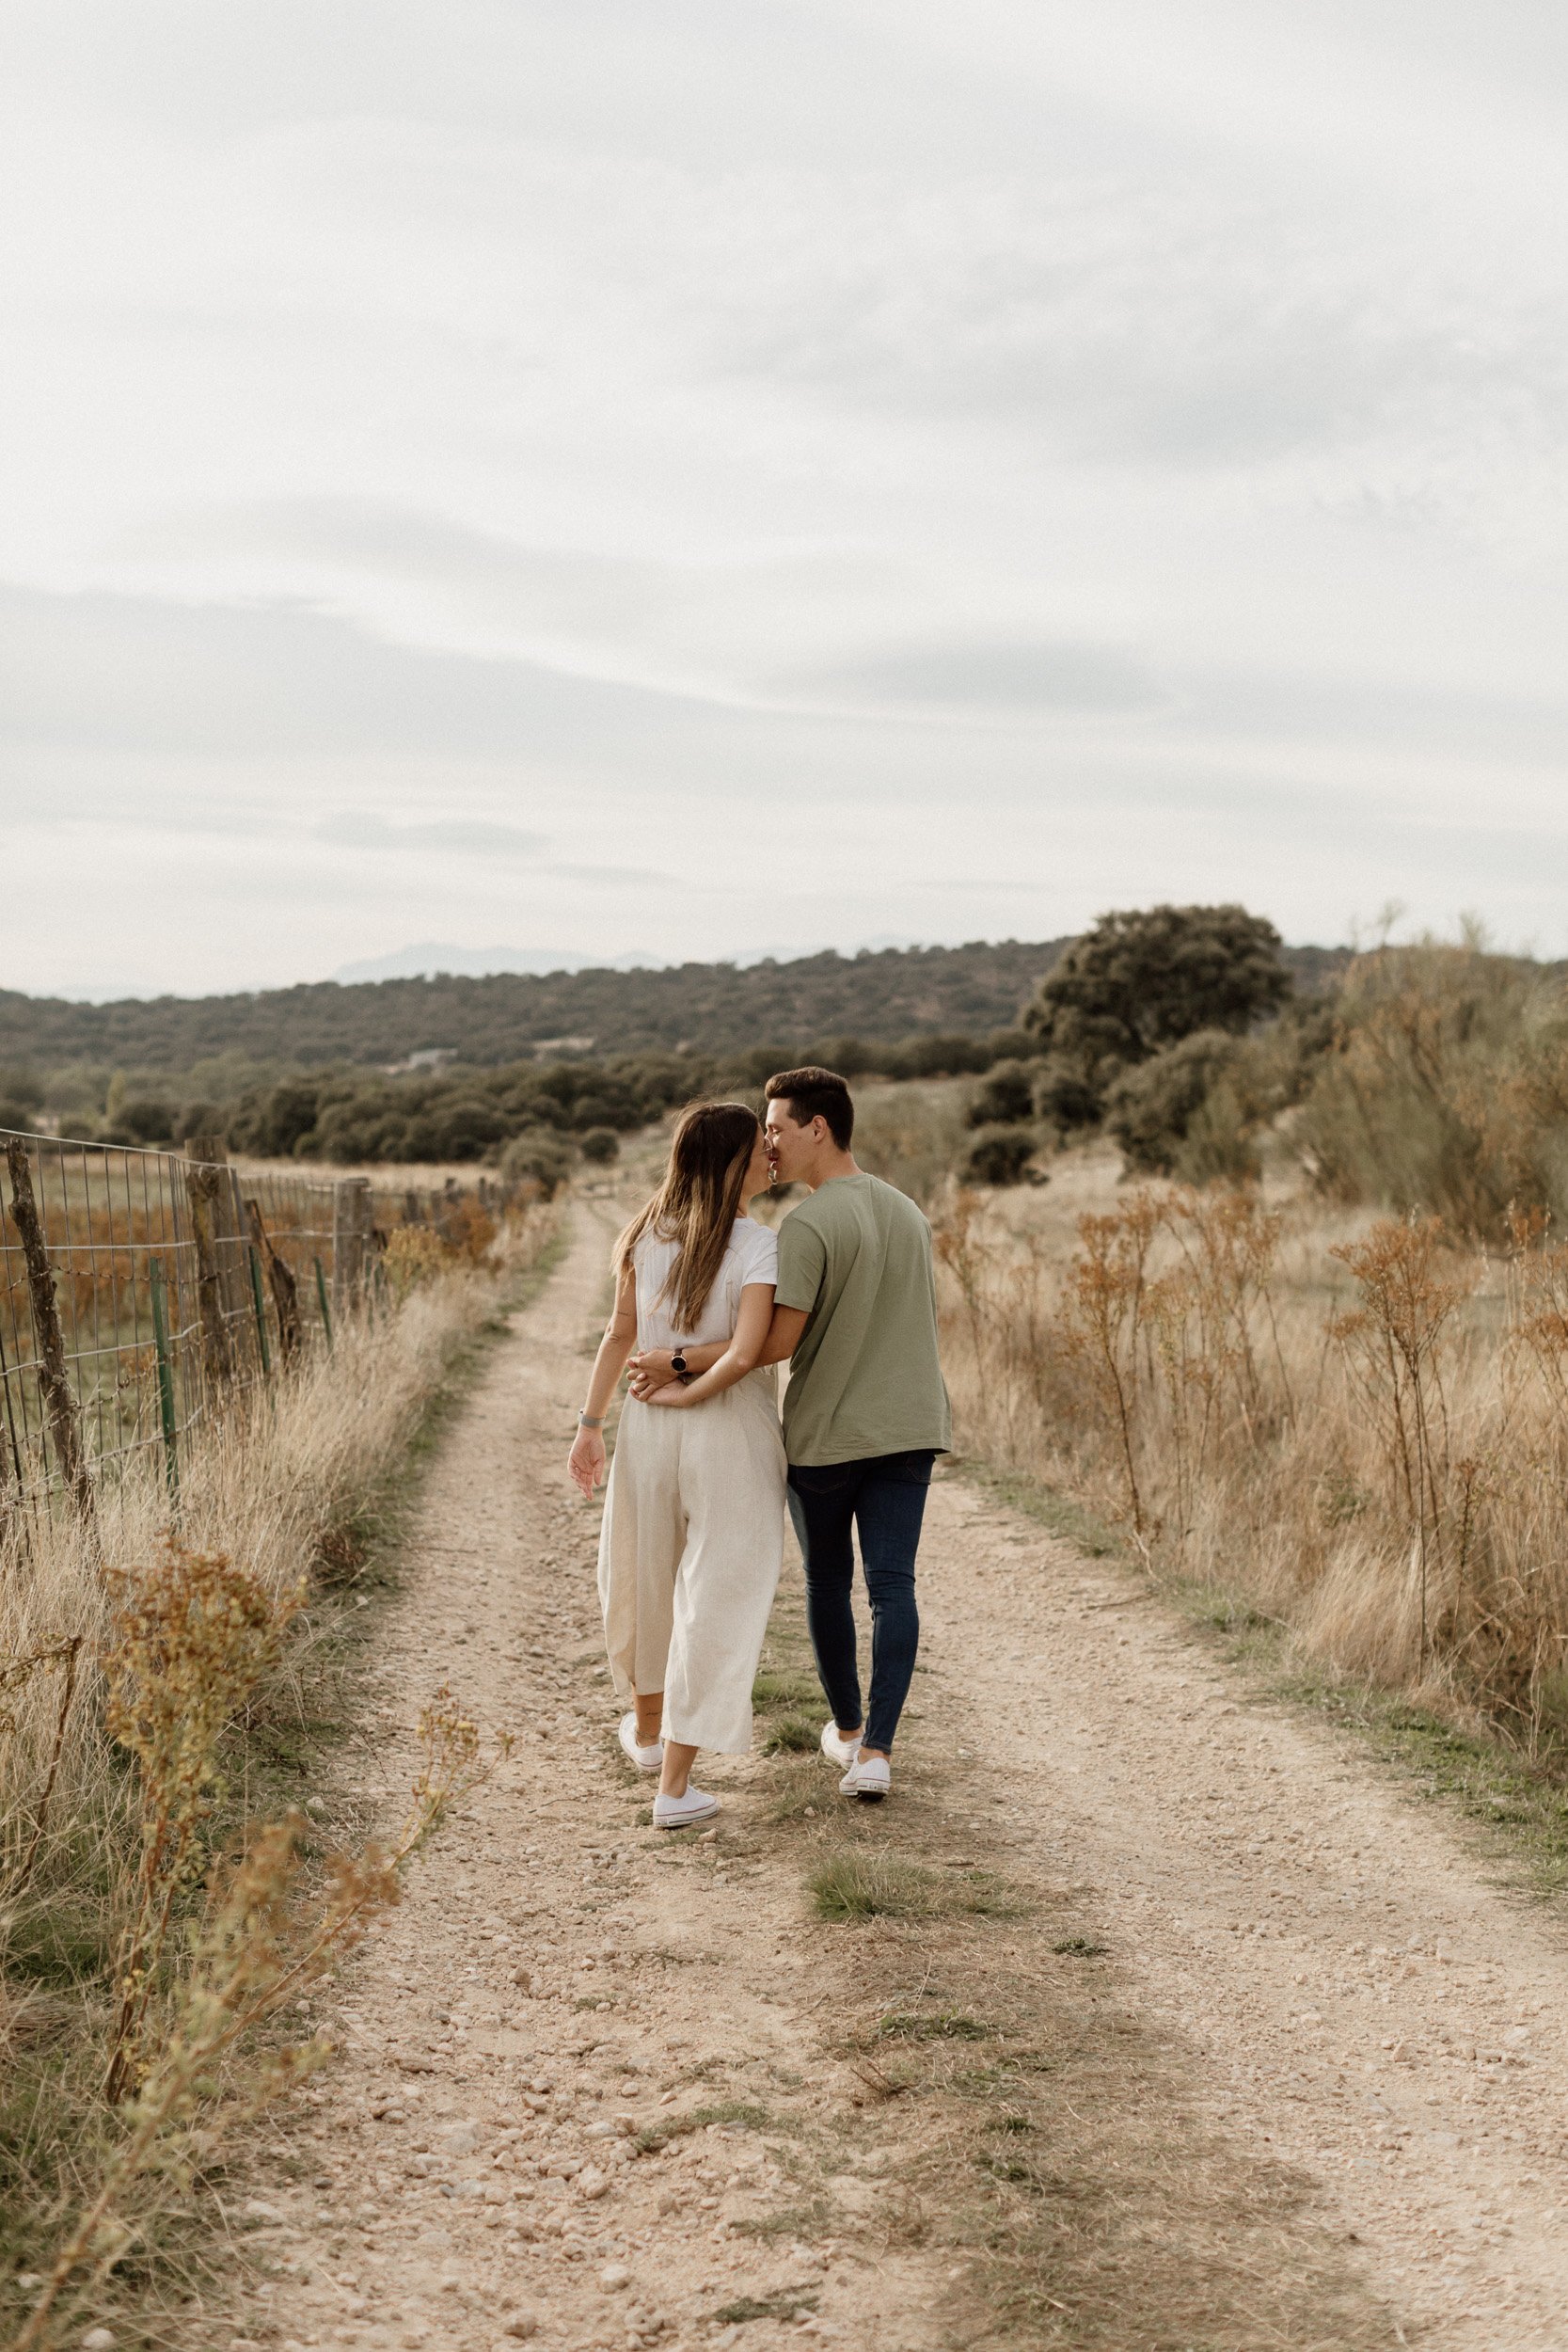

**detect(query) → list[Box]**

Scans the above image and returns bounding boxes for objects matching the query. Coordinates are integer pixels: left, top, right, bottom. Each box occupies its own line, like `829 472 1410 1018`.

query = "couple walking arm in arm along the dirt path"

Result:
569 1071 952 1830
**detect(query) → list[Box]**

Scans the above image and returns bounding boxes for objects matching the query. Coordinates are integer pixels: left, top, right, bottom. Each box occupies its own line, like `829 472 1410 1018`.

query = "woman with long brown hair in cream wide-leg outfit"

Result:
569 1104 785 1830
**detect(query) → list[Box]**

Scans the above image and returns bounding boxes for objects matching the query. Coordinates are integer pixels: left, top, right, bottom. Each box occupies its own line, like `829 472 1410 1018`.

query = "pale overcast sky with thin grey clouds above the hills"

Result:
0 0 1568 995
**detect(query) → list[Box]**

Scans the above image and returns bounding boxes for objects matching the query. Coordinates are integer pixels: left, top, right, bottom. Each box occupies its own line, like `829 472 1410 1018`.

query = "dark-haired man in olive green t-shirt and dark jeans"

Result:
632 1068 952 1804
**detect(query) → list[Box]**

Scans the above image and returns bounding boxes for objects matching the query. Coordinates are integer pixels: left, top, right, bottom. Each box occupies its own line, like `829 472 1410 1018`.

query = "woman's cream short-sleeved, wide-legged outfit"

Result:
599 1216 785 1755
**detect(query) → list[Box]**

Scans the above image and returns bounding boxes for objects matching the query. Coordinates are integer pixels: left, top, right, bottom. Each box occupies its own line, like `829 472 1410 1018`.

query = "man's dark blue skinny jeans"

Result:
790 1452 936 1753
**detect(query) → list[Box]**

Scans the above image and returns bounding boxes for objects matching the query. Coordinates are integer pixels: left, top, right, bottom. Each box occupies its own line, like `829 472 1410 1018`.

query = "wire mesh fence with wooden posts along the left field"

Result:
0 1129 510 1524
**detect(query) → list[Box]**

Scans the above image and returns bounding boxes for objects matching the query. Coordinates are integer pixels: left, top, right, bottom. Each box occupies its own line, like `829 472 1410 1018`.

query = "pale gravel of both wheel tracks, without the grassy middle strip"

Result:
227 1198 1568 2352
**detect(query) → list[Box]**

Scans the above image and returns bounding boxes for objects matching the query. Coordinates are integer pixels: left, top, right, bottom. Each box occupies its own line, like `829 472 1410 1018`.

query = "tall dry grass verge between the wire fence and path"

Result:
0 1207 555 2345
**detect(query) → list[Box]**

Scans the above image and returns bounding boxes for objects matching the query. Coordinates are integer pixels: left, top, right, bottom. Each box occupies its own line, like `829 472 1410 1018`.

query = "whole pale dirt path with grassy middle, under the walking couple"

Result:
227 1202 1568 2352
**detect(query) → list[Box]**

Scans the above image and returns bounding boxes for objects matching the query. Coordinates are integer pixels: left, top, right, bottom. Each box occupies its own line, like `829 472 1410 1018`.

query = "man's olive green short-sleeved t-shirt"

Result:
773 1176 952 1466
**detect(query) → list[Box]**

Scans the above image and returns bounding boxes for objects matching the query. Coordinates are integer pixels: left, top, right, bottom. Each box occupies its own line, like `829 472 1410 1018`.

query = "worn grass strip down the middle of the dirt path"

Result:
754 1505 1399 2352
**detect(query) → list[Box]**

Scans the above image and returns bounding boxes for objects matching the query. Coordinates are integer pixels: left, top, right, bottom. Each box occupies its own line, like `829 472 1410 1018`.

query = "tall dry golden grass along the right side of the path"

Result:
938 1185 1568 1755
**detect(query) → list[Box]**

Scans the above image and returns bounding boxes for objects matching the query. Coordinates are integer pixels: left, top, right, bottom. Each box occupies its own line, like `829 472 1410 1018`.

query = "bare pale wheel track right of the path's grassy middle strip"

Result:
922 1480 1568 2352
